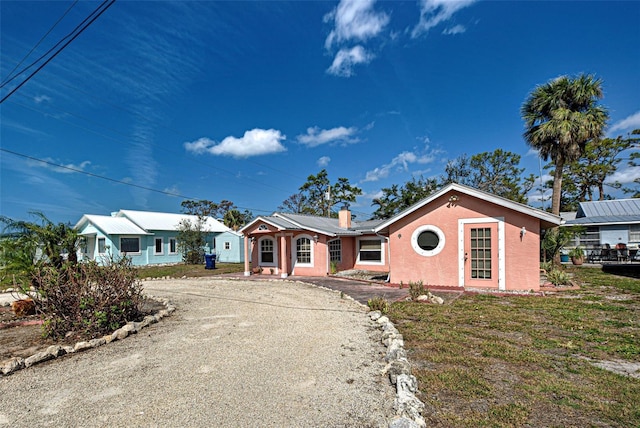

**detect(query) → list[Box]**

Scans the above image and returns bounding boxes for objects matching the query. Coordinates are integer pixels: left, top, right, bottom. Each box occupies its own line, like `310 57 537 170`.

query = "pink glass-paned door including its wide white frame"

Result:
458 217 506 290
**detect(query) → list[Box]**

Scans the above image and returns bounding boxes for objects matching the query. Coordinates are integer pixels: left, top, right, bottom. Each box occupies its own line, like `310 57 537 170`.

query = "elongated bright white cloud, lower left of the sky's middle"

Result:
184 128 287 158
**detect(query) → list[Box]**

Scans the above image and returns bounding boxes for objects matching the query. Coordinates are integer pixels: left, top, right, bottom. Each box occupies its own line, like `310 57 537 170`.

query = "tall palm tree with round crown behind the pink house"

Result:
521 74 609 215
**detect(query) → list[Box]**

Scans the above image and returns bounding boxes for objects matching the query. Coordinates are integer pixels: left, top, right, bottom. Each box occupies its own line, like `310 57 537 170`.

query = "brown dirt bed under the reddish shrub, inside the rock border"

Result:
0 299 164 365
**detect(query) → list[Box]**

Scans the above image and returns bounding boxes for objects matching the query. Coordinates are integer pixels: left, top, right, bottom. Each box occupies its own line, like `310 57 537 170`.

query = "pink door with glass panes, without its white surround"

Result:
463 222 502 288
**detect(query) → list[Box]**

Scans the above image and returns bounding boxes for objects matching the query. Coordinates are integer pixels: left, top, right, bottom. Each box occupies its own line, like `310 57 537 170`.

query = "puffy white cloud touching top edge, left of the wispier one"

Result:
324 0 389 49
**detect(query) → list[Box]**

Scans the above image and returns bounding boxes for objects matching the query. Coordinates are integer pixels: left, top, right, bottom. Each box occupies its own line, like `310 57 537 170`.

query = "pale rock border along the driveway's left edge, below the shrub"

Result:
0 295 176 378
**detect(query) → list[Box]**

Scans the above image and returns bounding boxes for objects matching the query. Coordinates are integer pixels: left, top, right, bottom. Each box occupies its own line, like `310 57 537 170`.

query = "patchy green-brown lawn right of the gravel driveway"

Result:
389 268 640 427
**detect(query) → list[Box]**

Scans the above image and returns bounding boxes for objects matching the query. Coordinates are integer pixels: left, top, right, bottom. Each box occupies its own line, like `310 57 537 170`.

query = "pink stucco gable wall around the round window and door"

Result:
389 192 540 290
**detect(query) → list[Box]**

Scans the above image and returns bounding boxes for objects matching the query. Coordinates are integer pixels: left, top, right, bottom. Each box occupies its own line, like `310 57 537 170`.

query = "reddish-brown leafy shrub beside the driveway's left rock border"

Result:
32 257 142 337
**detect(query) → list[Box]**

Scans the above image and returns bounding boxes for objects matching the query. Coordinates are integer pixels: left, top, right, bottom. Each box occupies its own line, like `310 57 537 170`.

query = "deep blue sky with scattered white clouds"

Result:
0 0 640 223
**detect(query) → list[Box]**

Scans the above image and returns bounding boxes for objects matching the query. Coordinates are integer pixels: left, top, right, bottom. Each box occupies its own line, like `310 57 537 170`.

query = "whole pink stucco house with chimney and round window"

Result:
241 183 561 291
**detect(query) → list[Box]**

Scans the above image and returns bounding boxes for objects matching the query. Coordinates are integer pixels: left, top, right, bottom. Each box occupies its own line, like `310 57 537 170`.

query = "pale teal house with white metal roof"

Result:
75 210 244 266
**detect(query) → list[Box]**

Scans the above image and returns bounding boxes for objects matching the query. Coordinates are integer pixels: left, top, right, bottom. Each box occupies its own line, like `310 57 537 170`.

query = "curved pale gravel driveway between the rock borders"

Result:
0 279 395 427
